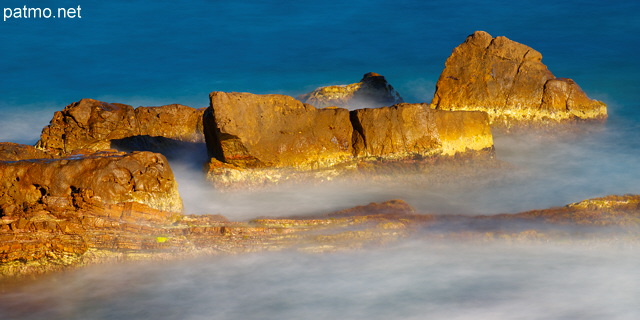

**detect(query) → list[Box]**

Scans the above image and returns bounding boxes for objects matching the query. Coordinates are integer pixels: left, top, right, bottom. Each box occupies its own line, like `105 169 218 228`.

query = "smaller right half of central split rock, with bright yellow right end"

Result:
351 103 493 159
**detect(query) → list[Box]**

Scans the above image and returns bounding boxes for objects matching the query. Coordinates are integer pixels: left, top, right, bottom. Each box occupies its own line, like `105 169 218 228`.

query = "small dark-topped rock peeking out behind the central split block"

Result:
298 72 404 109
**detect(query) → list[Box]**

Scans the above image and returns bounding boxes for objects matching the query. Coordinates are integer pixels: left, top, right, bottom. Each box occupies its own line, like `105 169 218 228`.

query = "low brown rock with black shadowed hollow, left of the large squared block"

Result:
37 99 204 155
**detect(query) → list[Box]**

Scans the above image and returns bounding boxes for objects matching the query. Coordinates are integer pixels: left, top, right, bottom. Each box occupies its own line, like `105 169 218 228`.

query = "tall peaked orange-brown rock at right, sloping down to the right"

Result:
432 31 607 128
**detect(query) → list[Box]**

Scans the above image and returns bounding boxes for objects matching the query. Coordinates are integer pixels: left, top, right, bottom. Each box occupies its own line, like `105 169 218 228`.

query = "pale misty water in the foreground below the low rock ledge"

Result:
0 240 640 320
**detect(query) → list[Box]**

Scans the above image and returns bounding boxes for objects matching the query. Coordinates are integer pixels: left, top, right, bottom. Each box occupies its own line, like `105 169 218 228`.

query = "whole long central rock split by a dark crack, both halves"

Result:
203 92 493 187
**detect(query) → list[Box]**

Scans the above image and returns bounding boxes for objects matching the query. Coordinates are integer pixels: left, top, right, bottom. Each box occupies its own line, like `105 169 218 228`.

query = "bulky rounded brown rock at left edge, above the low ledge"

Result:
0 152 182 217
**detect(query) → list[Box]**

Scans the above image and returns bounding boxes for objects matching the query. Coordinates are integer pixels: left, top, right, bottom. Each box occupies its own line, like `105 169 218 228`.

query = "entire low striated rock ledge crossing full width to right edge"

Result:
5 195 640 278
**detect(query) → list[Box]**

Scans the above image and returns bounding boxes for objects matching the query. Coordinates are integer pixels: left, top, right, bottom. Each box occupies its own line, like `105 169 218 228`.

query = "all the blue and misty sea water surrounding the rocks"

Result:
0 0 640 319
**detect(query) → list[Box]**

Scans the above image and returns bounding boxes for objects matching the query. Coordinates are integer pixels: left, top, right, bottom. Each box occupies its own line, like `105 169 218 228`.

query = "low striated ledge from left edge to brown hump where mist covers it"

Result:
0 201 428 279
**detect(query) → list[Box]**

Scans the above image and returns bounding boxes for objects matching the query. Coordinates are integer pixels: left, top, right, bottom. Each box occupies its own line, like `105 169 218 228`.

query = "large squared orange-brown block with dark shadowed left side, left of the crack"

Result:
204 92 353 170
